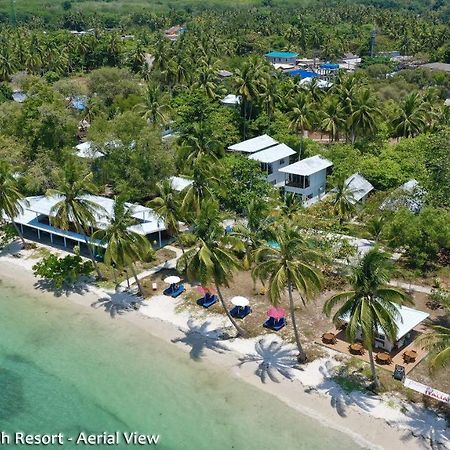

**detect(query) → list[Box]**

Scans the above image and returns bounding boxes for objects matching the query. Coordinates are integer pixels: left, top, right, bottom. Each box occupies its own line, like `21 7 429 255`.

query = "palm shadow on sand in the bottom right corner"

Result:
400 405 450 450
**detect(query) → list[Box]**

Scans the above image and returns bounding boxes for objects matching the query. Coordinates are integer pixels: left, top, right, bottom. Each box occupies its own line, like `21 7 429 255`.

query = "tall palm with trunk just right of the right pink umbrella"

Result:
253 222 322 363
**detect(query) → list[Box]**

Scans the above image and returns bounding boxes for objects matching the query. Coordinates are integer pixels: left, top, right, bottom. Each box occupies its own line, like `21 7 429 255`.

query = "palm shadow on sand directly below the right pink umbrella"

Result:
238 339 300 383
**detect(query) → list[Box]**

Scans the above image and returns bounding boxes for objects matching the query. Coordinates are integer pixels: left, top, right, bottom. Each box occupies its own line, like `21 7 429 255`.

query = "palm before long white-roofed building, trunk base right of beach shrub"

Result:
46 162 105 279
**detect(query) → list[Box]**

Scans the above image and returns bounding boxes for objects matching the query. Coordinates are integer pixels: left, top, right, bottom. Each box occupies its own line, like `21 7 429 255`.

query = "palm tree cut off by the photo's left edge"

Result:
0 161 26 247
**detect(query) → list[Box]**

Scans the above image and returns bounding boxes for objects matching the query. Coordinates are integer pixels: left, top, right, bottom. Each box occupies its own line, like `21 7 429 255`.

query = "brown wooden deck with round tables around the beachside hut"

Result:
320 329 428 374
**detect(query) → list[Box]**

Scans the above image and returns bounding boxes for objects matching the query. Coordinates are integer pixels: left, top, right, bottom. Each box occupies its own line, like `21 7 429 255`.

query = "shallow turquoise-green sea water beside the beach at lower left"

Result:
0 282 359 450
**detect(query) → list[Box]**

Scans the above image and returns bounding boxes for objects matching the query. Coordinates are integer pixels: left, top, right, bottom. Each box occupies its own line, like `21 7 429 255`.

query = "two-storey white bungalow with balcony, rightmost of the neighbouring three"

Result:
280 155 333 201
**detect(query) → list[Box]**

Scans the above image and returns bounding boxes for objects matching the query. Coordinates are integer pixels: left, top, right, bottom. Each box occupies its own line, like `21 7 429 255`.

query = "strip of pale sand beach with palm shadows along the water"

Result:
0 252 450 450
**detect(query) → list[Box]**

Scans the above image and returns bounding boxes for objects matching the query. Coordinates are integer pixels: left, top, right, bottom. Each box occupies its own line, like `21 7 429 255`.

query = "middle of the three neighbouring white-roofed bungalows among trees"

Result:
249 144 297 185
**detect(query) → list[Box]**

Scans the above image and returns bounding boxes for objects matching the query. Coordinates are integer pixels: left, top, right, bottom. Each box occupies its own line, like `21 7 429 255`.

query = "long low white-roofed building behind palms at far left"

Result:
10 195 166 248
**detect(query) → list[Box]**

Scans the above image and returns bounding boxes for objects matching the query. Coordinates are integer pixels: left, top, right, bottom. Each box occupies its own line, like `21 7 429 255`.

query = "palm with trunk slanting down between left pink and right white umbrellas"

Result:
177 200 246 336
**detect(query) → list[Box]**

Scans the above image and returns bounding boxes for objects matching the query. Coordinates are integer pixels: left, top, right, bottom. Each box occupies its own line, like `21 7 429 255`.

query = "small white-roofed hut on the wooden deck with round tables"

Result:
342 306 429 353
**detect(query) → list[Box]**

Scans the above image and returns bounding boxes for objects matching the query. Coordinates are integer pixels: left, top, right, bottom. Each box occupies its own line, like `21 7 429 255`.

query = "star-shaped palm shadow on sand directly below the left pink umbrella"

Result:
172 319 229 361
